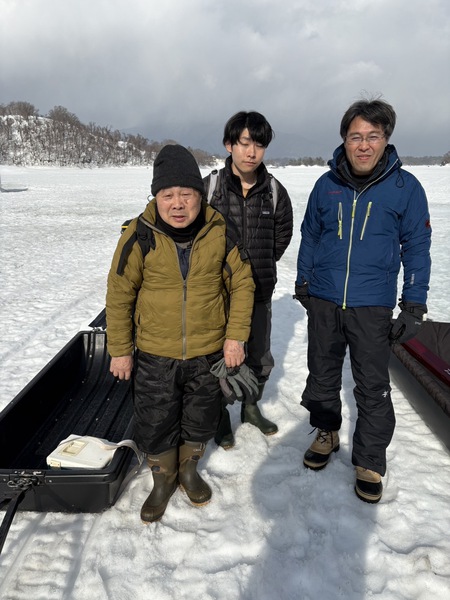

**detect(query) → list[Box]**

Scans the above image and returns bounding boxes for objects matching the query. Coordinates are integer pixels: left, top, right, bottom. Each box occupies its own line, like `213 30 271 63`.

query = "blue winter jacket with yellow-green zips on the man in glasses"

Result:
296 145 431 309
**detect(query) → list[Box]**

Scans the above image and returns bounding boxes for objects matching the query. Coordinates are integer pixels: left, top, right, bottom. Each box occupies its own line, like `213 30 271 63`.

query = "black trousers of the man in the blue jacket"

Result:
301 298 395 475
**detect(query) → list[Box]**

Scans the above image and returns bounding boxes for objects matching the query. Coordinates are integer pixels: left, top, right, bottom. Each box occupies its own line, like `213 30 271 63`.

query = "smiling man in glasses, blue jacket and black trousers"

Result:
294 99 431 503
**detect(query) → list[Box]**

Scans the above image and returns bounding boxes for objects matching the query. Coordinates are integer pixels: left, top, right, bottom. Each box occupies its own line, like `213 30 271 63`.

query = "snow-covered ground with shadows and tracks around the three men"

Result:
0 167 450 600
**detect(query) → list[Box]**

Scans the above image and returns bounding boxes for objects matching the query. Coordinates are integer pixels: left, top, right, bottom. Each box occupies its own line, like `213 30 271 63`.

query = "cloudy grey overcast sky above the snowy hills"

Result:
0 0 450 158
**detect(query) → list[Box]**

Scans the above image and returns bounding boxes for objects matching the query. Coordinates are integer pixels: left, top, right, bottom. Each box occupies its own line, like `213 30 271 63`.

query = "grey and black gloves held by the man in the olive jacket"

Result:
210 358 259 404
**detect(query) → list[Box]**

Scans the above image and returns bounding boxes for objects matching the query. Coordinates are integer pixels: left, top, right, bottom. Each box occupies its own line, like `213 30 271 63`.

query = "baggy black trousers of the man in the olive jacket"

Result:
134 351 223 454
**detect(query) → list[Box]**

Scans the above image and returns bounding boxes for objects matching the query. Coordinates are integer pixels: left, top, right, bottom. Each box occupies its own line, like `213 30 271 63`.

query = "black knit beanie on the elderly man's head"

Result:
151 145 205 196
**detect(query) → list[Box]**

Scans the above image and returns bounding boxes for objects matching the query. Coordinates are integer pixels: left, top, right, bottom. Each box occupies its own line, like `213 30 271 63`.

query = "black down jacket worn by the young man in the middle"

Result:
204 157 293 302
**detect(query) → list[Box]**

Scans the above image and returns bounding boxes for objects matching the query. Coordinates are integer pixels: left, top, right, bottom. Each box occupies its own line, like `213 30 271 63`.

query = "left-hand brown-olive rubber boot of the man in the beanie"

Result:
141 448 178 523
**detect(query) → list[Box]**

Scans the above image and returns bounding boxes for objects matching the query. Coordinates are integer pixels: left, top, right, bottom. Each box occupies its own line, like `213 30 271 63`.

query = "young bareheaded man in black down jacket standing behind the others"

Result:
204 111 293 449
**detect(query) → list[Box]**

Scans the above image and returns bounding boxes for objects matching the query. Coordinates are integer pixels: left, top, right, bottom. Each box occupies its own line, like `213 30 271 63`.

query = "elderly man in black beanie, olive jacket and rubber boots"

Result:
106 145 254 523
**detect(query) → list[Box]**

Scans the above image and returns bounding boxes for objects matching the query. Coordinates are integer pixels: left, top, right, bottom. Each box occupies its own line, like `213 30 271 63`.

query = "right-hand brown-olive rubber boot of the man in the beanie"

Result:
178 442 212 506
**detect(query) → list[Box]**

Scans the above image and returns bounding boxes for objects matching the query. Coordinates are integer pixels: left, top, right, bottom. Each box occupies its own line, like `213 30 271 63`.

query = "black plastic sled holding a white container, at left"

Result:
0 313 134 552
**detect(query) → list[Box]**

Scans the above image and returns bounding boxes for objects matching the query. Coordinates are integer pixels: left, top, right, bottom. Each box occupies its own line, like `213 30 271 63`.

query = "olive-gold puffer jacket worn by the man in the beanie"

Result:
106 200 255 360
